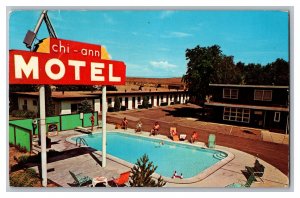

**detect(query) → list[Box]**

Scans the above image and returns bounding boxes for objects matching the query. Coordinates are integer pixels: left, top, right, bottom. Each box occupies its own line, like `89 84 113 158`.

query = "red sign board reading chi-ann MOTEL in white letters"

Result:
9 39 126 85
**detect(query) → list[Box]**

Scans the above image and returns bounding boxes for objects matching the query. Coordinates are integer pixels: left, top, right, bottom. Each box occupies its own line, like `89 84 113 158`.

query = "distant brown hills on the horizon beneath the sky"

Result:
126 77 184 85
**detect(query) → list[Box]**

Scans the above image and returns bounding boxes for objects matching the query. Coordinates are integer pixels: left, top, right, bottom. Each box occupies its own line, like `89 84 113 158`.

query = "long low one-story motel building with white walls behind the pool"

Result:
11 90 189 115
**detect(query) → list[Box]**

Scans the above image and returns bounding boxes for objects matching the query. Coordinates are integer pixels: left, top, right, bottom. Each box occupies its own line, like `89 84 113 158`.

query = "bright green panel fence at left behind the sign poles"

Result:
9 112 98 151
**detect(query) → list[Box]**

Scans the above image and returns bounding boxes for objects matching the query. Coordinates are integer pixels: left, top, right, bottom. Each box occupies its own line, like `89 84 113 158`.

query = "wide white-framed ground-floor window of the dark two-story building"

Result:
223 107 250 123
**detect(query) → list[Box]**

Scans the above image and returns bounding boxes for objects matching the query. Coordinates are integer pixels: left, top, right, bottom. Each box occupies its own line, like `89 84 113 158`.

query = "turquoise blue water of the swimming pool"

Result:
72 132 227 178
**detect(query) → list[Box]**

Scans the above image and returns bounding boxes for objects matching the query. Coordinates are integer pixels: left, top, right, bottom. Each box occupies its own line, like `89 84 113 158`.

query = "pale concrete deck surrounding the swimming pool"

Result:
34 124 289 188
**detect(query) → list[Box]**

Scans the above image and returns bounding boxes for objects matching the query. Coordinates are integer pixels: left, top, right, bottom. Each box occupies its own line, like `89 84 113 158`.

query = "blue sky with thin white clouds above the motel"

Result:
9 10 289 77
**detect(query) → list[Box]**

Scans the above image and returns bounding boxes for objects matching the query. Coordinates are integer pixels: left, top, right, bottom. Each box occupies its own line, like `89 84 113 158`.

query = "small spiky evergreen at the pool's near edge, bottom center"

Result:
129 154 166 187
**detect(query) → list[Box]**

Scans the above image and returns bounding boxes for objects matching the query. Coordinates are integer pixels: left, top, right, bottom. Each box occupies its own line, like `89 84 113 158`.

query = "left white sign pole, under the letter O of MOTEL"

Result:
40 85 47 187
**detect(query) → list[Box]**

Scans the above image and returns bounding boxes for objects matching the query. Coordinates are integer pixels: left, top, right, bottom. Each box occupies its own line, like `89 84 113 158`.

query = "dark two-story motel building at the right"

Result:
204 84 289 134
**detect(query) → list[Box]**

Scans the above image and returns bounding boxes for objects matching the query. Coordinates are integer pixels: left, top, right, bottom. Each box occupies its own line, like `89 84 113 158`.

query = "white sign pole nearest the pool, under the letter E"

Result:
102 86 107 167
